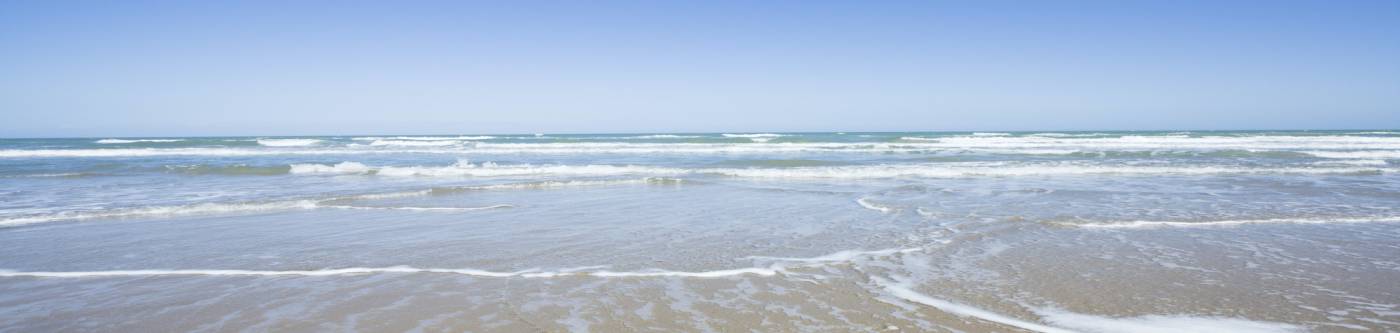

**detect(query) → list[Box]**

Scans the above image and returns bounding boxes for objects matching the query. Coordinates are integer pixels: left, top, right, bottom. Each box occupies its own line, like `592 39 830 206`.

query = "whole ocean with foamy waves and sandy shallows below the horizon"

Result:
0 130 1400 332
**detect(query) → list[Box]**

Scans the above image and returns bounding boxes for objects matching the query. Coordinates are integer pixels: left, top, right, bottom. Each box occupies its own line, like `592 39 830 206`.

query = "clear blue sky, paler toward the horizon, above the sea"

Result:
0 0 1400 137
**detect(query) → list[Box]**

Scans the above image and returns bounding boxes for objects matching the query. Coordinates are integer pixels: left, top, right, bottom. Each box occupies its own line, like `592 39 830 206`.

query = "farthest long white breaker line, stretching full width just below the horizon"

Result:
8 133 1400 160
